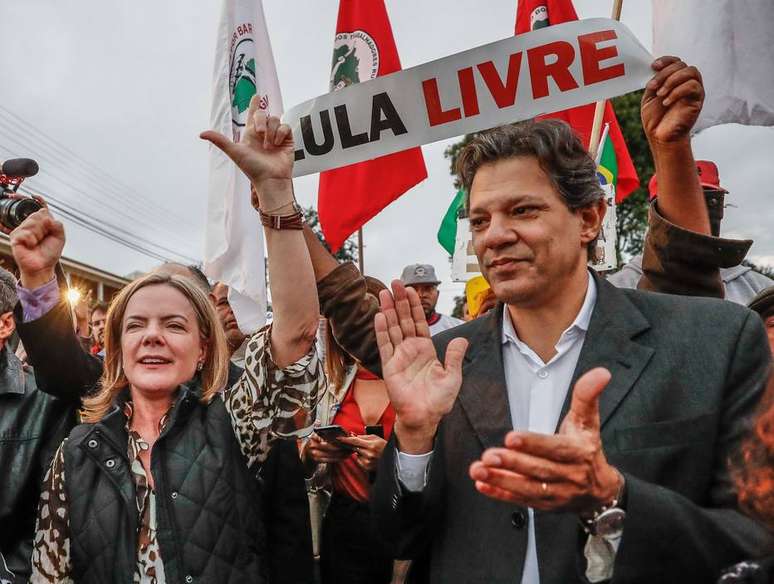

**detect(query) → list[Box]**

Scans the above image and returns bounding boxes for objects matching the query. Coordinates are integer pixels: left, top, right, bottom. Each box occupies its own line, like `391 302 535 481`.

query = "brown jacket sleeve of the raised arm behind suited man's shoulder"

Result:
637 201 752 298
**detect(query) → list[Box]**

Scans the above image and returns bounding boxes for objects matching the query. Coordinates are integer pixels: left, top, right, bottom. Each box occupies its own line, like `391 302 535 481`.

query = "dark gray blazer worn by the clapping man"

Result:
372 275 771 584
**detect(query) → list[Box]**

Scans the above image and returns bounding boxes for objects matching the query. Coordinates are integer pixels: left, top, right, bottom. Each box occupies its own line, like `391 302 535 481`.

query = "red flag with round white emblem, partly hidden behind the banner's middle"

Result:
317 0 427 251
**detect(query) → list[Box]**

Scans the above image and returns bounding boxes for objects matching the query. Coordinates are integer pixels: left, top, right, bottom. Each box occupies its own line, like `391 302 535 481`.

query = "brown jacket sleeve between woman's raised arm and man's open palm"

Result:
317 263 386 377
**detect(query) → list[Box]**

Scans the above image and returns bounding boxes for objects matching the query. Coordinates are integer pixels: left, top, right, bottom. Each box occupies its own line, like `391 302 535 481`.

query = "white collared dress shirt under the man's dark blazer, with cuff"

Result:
396 276 617 584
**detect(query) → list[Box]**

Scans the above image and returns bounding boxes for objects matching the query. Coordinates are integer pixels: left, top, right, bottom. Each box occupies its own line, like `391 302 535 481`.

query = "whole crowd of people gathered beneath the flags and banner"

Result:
0 57 774 584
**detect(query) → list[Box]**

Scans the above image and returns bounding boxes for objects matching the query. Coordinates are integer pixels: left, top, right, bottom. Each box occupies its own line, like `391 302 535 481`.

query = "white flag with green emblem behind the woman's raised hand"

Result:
204 0 282 334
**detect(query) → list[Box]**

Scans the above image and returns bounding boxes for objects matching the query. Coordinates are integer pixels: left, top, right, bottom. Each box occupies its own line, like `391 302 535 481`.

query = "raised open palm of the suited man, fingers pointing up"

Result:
374 280 468 454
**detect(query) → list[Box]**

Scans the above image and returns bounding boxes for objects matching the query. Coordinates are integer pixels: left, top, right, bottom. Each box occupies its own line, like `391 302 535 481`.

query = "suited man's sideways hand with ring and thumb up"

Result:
470 368 623 514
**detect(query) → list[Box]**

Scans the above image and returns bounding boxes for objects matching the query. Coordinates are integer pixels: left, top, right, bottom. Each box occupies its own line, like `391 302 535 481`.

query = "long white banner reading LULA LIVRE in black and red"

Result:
284 18 653 176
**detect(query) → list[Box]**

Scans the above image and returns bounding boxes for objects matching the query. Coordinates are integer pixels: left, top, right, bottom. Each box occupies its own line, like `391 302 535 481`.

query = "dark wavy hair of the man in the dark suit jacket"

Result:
457 120 605 254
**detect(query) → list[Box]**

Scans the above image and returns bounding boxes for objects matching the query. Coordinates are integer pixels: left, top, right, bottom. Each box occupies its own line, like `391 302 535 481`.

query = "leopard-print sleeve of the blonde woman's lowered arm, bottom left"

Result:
29 442 73 584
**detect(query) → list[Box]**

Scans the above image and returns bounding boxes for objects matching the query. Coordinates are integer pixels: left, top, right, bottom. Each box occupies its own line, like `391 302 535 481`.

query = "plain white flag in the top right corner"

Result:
653 0 774 132
